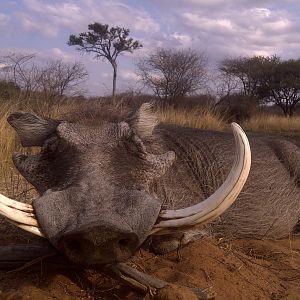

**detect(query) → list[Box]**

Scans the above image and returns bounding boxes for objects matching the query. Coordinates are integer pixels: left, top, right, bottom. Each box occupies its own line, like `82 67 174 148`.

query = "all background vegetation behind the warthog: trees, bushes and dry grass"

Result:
0 39 300 196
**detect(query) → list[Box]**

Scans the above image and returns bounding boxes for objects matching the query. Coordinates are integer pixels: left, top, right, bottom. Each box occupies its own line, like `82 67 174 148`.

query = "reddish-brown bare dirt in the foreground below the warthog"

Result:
0 237 300 300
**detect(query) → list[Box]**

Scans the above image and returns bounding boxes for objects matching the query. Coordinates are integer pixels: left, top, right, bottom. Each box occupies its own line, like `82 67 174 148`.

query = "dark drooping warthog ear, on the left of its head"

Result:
7 112 59 147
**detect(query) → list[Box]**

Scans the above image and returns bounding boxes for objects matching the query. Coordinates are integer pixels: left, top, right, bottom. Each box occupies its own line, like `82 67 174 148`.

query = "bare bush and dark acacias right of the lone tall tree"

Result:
137 49 300 116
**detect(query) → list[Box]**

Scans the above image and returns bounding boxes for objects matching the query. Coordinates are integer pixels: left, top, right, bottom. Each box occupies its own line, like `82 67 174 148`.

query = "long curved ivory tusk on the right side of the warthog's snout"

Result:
150 123 251 234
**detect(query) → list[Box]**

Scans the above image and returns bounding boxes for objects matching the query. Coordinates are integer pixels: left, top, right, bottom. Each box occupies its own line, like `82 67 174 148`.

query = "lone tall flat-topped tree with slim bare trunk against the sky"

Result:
68 22 142 98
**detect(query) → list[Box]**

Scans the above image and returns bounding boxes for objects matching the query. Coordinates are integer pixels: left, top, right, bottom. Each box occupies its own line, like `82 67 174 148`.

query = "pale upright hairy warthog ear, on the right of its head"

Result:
129 103 158 138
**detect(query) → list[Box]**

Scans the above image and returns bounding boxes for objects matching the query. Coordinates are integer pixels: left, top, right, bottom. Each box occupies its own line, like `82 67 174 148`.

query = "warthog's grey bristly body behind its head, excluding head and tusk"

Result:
156 125 300 239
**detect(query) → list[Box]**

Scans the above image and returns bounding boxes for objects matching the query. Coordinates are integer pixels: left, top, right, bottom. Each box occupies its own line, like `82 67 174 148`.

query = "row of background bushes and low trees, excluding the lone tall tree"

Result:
0 48 300 120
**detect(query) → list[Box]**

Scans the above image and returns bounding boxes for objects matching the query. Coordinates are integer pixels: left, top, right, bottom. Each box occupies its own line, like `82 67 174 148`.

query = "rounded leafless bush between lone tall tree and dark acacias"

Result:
137 48 207 101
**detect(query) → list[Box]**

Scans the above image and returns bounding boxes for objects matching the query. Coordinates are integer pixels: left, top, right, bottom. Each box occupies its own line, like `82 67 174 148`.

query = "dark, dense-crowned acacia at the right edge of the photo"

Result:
219 55 300 117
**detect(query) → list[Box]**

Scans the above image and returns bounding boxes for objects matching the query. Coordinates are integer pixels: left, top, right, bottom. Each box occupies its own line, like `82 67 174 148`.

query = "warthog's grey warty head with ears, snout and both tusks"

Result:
0 104 250 266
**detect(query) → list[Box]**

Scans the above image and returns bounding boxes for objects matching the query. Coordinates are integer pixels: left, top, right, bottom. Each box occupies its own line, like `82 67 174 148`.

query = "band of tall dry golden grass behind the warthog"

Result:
0 94 300 190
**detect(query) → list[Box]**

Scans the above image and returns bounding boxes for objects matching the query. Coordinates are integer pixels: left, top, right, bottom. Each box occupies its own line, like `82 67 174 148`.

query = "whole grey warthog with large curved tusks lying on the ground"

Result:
0 103 300 266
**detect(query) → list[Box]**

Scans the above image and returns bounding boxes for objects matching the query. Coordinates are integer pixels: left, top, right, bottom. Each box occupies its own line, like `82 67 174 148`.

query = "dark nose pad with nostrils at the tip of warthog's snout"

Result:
58 222 139 266
